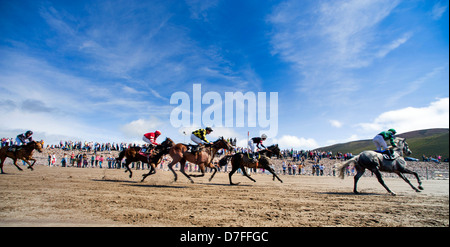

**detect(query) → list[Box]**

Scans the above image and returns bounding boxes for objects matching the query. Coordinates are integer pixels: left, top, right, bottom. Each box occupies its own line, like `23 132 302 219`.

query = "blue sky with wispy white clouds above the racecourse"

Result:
0 0 449 149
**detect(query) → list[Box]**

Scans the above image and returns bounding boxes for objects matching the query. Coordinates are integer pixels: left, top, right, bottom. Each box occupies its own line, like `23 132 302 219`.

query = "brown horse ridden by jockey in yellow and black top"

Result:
168 137 233 183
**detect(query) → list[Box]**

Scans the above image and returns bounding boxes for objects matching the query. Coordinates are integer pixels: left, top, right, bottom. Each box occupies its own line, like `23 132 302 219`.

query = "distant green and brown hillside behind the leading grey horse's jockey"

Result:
316 129 449 159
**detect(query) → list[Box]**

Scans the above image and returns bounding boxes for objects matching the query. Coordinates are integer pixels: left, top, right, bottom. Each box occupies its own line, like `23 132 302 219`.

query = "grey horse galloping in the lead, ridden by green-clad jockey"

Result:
338 137 423 196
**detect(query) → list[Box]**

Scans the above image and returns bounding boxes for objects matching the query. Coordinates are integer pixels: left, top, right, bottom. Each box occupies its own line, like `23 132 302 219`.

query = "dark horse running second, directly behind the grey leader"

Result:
219 144 283 185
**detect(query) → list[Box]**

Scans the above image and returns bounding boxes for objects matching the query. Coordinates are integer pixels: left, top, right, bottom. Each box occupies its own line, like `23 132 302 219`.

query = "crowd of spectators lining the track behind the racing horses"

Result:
1 138 441 179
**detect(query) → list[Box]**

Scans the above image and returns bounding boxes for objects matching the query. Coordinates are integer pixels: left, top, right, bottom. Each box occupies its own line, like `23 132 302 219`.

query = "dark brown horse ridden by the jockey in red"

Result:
116 138 173 178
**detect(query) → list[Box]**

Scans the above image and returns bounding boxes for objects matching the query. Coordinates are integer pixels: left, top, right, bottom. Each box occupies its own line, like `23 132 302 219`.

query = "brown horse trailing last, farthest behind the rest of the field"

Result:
0 141 44 174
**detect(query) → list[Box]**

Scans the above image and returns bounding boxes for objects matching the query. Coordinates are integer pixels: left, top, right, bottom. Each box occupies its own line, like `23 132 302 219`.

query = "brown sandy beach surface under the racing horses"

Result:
0 162 449 227
